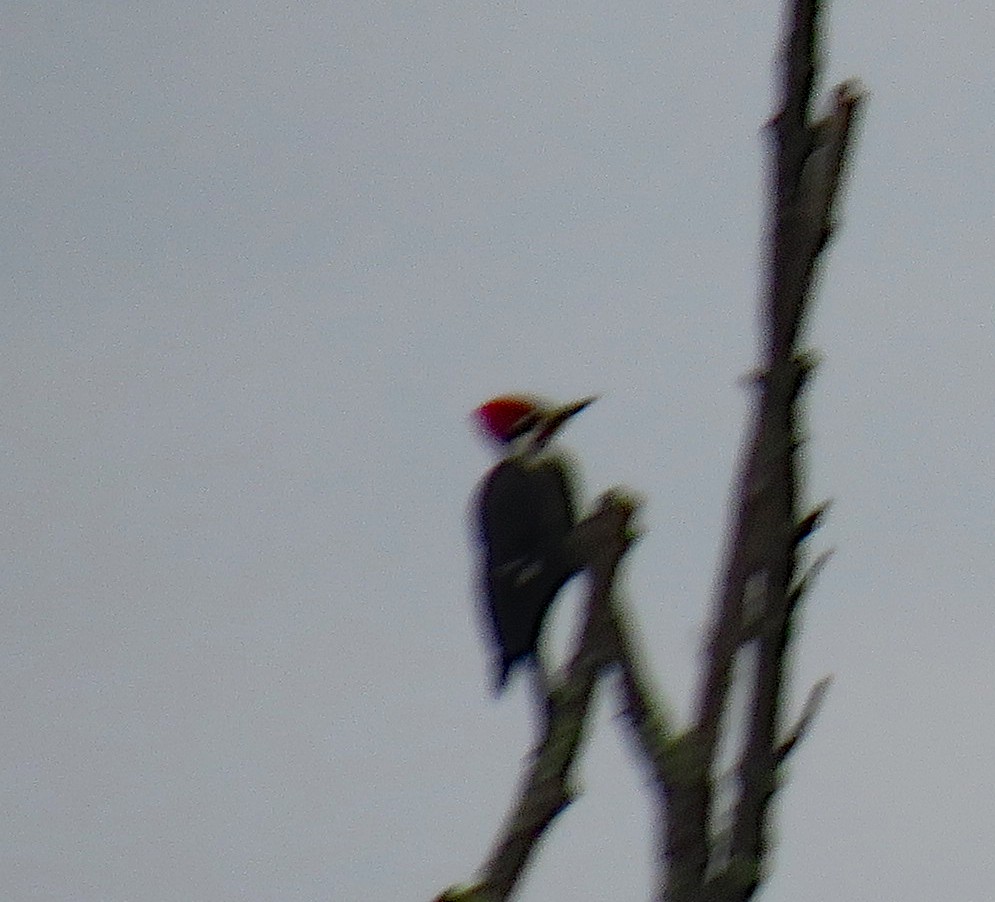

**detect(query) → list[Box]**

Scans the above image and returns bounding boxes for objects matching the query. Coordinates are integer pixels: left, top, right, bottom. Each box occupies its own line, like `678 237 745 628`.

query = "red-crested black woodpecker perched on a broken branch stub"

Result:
476 395 594 692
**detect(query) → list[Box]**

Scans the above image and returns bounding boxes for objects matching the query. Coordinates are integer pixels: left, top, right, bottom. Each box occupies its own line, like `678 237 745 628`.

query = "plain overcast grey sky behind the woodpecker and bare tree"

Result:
0 0 995 902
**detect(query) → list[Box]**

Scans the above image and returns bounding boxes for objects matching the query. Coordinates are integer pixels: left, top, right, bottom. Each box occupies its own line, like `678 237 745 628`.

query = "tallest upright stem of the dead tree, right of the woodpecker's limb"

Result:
665 0 861 902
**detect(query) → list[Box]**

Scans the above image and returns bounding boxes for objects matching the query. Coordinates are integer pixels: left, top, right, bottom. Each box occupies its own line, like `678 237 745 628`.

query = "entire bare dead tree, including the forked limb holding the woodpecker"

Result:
438 0 862 902
